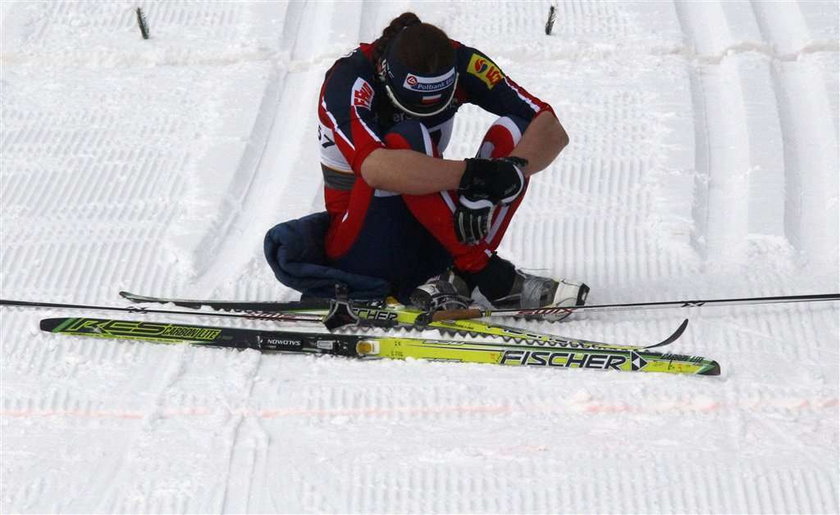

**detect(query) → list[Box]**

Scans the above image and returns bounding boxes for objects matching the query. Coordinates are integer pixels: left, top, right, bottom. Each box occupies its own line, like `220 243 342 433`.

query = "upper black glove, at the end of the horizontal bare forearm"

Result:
458 156 528 207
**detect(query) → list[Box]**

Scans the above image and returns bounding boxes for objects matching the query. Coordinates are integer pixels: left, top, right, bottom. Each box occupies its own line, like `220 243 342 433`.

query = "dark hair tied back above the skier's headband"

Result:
373 12 455 73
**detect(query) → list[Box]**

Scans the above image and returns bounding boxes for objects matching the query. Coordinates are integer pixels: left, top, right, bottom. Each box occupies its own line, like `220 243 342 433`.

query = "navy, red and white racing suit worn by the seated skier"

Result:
274 41 553 298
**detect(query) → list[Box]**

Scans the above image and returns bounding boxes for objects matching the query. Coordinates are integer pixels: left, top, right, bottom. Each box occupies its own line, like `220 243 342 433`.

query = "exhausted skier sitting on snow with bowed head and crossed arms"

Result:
265 13 589 309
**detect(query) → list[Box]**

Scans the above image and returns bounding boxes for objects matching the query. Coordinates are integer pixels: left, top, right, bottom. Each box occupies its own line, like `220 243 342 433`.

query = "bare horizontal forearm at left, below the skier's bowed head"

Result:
362 148 465 195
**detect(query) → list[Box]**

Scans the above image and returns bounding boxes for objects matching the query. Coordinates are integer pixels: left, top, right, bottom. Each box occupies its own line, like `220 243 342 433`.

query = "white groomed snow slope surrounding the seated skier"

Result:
0 0 840 513
